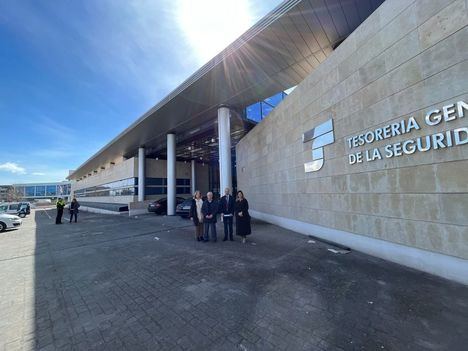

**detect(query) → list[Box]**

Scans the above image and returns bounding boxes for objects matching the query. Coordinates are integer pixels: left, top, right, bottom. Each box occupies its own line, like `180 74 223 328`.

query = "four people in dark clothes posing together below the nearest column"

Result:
190 188 252 244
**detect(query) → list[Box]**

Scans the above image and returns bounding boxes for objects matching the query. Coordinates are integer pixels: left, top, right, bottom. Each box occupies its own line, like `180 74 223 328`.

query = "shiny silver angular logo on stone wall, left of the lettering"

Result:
302 118 335 173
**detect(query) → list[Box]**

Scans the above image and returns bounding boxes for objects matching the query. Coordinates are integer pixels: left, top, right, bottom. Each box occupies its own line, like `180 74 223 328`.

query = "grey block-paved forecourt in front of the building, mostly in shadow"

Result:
0 210 468 351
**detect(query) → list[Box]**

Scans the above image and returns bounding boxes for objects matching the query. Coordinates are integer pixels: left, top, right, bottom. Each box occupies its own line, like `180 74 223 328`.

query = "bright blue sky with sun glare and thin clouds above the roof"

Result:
0 0 281 184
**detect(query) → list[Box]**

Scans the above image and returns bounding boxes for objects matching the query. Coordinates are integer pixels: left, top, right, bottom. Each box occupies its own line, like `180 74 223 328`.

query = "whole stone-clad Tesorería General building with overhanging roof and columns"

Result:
69 0 468 284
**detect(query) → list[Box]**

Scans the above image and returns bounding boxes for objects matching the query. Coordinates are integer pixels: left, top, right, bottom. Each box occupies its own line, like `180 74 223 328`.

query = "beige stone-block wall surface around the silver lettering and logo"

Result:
237 0 468 259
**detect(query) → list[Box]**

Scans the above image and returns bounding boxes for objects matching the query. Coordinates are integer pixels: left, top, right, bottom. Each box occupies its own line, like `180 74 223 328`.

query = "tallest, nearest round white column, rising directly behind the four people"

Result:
218 106 232 195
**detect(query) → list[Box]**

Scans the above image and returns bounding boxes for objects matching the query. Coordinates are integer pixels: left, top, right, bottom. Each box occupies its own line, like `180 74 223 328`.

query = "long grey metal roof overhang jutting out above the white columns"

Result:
68 0 384 179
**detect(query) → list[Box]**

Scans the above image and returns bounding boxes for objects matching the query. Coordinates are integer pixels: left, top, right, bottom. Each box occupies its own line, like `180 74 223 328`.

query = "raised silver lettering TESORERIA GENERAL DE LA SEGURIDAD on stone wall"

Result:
346 101 468 165
